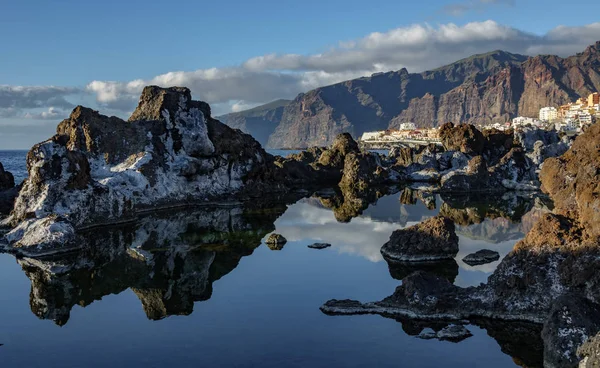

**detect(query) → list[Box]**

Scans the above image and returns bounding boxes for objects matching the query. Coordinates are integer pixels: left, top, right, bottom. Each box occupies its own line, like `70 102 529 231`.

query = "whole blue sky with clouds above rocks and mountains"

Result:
0 0 600 150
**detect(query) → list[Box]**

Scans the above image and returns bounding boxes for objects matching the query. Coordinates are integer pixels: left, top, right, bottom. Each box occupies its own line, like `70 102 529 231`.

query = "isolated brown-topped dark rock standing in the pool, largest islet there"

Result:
381 216 458 262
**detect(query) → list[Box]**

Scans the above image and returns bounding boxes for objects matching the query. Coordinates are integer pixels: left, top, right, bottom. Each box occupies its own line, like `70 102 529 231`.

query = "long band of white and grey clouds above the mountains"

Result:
0 20 600 124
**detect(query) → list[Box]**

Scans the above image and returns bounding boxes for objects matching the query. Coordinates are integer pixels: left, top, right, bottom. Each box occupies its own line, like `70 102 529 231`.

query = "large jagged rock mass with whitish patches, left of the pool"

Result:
7 86 280 255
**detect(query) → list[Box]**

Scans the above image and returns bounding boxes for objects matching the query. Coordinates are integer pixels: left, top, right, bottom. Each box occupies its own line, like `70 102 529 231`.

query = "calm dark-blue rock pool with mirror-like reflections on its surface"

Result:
0 153 544 367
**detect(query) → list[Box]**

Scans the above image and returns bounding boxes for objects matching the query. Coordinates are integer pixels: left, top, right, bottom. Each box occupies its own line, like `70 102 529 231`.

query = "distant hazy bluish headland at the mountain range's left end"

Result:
217 100 291 146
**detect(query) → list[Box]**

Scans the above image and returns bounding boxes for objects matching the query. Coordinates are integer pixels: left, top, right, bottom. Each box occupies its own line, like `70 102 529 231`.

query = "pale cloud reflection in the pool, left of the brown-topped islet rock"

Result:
275 201 412 262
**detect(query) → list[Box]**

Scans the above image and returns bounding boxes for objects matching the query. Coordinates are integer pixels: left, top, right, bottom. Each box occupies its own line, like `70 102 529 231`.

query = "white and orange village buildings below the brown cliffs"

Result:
360 92 600 146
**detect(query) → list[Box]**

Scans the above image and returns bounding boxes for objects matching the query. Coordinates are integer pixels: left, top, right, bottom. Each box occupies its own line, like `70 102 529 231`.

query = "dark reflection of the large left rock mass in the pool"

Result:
19 206 285 325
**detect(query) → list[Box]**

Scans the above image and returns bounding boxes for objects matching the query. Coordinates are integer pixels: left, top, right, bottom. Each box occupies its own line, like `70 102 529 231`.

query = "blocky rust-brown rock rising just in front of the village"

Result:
439 123 485 155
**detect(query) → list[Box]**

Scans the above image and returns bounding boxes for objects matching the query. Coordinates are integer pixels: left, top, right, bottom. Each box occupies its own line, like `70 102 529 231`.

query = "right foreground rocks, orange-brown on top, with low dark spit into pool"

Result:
321 121 600 367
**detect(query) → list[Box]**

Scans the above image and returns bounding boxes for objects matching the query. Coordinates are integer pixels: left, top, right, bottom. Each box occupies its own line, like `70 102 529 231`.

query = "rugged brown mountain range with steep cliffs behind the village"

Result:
218 41 600 148
